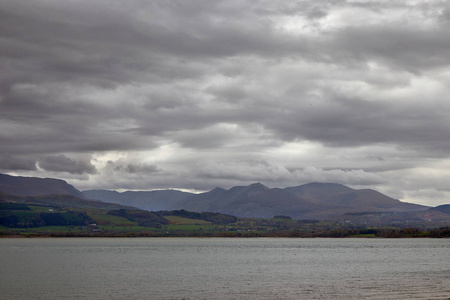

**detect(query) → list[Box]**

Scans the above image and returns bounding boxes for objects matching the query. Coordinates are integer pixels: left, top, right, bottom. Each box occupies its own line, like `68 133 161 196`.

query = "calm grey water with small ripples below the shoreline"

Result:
0 238 450 299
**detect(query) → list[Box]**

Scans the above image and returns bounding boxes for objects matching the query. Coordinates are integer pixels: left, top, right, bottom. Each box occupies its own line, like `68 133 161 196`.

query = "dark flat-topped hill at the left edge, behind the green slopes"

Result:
0 174 83 198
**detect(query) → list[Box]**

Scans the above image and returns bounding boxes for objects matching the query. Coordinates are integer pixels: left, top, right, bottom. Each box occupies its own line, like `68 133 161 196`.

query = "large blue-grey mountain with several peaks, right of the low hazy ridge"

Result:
167 183 428 219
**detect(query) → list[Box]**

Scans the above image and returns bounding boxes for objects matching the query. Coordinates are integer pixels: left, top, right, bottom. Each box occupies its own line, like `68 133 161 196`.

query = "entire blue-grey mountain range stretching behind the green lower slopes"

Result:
0 174 436 219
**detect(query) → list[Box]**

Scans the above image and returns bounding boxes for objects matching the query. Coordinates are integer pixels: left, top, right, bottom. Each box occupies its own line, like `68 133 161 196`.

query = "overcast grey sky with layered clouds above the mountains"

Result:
0 0 450 206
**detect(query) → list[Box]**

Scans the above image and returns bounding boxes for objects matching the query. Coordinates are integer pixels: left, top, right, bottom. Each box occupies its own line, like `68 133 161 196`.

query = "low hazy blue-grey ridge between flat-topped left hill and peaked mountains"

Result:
83 190 193 211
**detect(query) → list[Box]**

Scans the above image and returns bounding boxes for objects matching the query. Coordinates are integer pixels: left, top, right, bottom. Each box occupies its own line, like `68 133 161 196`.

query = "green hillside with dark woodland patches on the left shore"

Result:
0 193 241 236
